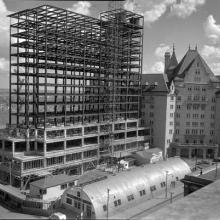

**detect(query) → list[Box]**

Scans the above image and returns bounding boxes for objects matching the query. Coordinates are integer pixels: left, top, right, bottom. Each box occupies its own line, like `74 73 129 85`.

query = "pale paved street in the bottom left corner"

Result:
0 204 48 219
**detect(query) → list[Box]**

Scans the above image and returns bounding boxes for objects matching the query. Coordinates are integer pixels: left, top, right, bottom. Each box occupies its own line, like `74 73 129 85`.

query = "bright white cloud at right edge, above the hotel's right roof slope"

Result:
204 15 220 44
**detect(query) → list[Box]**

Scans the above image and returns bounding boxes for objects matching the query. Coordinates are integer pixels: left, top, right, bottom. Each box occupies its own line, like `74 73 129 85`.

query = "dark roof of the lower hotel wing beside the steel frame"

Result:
141 73 169 92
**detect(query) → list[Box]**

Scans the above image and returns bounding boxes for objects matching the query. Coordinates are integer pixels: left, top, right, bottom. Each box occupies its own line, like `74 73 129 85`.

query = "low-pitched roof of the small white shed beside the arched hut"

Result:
30 174 79 189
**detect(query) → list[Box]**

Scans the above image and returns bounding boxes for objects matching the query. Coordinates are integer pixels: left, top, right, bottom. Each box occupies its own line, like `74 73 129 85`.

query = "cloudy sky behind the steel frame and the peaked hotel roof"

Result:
0 0 220 88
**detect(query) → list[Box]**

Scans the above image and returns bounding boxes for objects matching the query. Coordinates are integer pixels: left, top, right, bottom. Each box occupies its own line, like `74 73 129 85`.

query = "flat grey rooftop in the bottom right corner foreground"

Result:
142 177 220 220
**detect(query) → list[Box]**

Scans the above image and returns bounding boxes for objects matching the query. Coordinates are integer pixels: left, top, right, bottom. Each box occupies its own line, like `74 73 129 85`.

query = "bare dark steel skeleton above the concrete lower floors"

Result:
9 5 143 131
